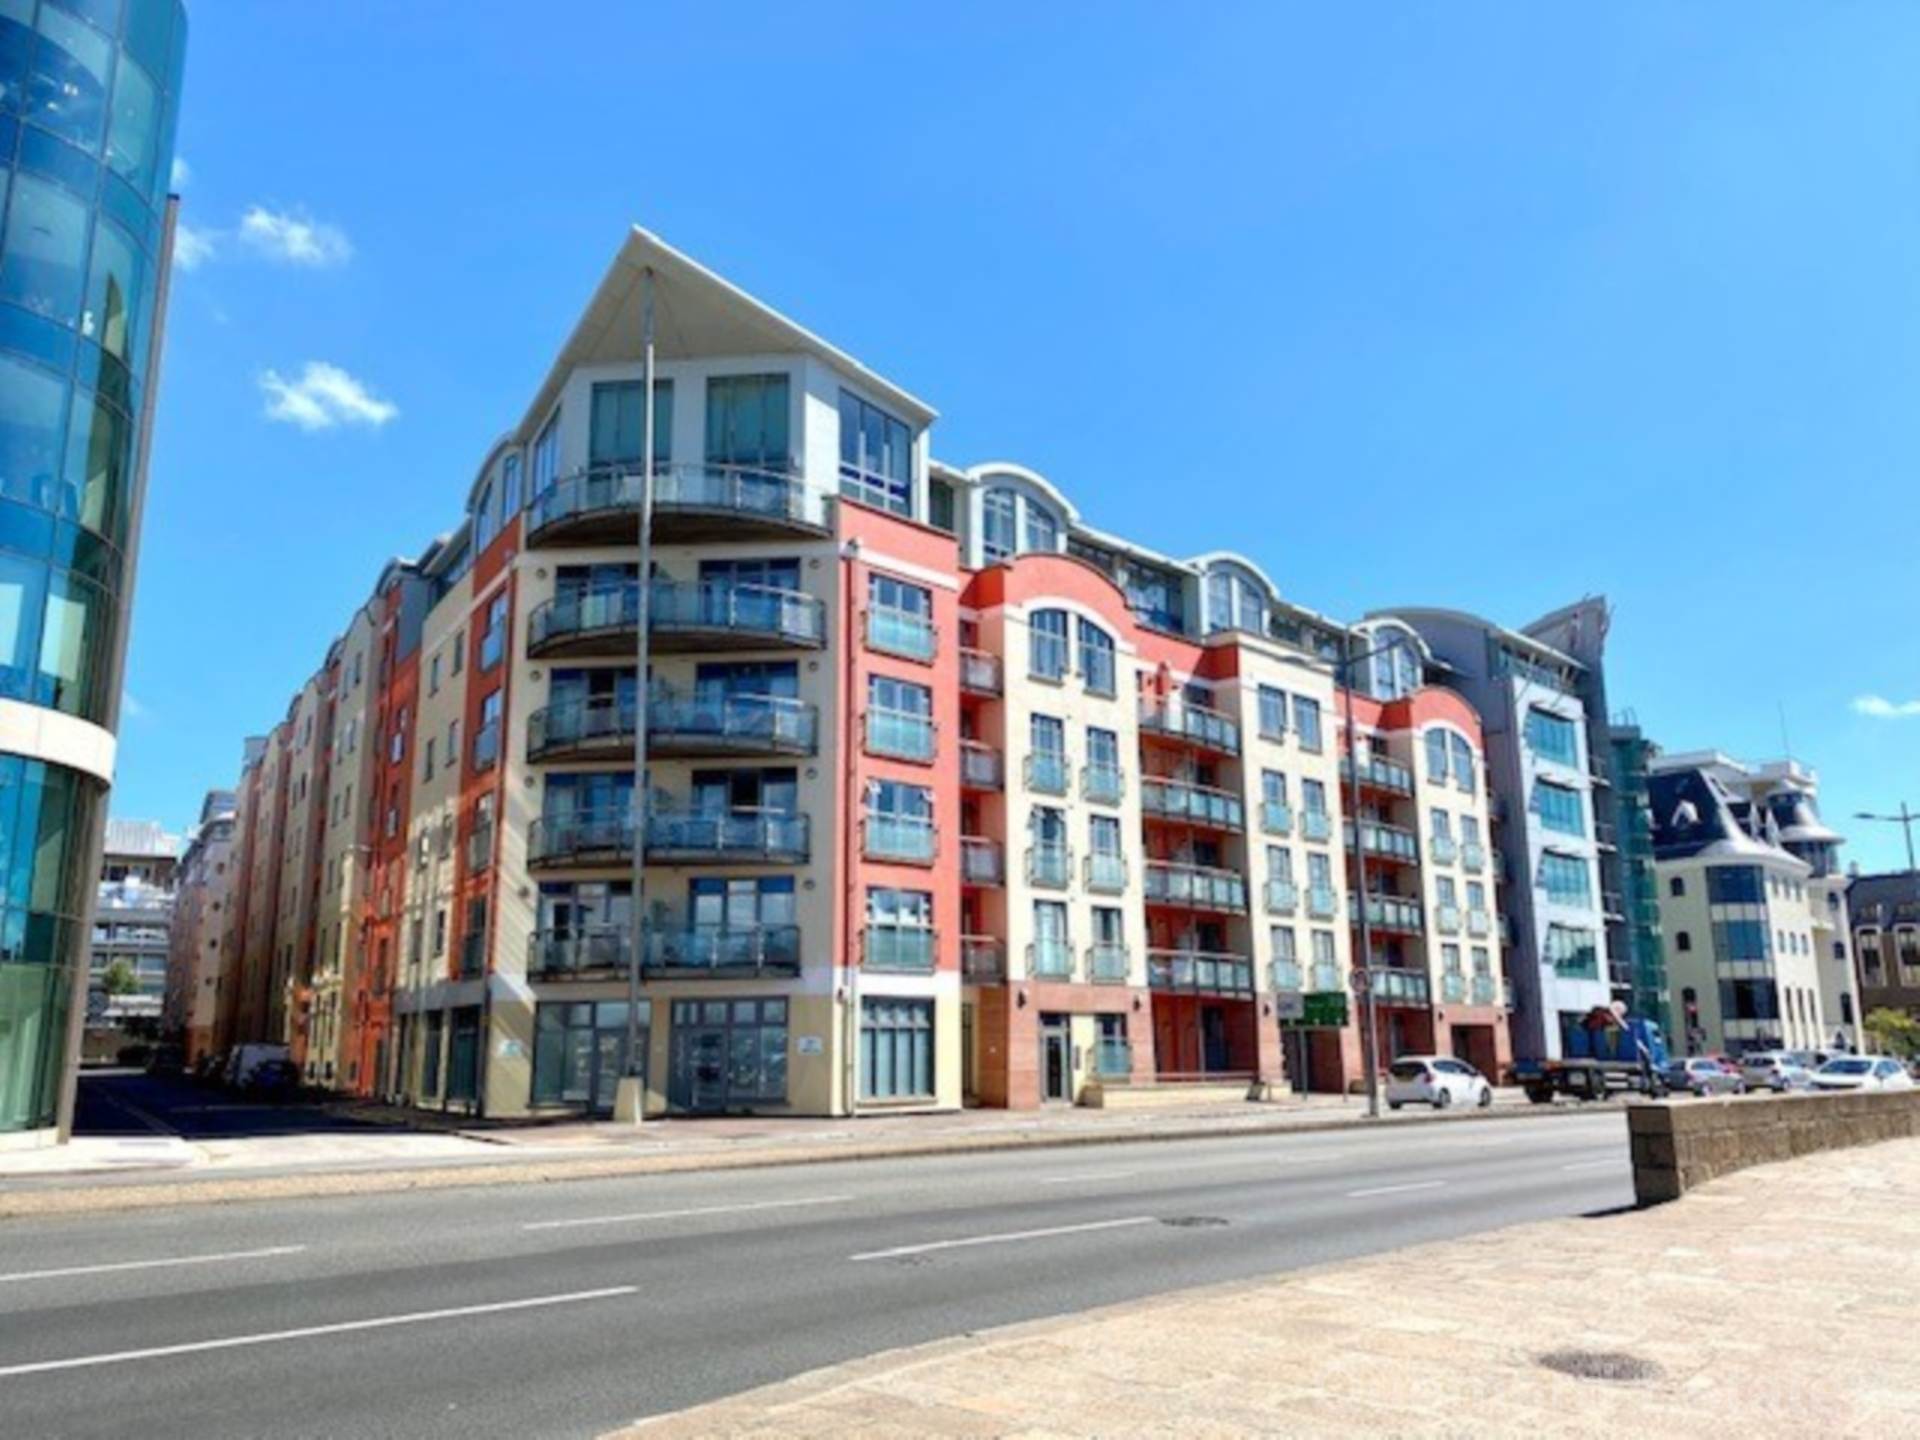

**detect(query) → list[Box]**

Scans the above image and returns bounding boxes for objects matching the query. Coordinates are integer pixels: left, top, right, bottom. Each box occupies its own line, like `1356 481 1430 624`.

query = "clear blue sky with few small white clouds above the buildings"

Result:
127 0 1920 868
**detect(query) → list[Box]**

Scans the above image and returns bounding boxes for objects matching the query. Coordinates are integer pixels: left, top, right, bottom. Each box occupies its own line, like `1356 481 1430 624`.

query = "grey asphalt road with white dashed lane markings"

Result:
0 1114 1632 1440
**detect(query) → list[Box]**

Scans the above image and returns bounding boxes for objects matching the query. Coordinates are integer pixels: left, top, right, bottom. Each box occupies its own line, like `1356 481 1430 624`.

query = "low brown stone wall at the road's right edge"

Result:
1626 1091 1920 1206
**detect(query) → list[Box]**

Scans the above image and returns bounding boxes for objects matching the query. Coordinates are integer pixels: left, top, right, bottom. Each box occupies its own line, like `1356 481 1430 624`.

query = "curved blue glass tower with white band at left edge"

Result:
0 0 186 1144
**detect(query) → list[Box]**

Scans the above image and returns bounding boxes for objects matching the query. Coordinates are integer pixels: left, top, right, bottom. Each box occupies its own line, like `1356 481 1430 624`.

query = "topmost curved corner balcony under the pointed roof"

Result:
526 461 826 549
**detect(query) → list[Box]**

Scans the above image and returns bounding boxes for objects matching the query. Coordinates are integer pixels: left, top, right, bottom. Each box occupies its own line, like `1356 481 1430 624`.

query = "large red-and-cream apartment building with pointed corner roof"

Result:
206 230 1511 1116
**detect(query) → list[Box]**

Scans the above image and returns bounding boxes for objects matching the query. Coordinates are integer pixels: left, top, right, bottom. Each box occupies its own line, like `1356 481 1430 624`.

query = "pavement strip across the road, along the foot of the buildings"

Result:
0 1071 1589 1219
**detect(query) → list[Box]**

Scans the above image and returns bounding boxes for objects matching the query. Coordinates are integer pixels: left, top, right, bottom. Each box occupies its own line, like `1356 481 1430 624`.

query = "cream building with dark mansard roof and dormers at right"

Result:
1649 751 1860 1054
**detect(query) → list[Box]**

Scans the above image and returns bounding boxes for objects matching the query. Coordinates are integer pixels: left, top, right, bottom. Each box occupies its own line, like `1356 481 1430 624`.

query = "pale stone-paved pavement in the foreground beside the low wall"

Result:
624 1140 1920 1440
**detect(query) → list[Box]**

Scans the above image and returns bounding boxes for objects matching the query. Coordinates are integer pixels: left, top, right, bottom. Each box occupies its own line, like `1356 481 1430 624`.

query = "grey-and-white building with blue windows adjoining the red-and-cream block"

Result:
1375 609 1630 1060
